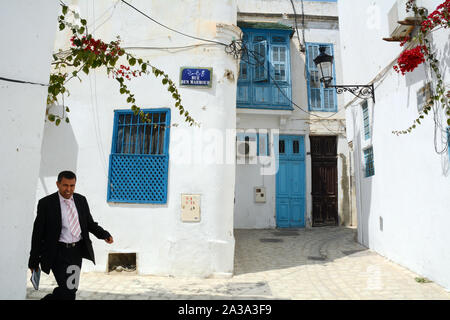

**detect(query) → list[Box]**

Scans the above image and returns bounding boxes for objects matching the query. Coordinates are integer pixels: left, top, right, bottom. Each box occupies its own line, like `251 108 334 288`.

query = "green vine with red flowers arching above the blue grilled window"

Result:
47 4 199 126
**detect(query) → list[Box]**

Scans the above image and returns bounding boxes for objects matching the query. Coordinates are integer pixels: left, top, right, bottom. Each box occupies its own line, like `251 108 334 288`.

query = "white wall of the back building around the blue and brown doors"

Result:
234 0 351 228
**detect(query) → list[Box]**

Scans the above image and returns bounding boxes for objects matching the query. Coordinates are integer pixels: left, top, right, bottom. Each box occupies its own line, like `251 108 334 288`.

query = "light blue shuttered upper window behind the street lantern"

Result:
306 43 337 112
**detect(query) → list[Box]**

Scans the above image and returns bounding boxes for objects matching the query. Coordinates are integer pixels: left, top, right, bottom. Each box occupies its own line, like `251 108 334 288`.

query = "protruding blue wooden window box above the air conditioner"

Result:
237 27 293 110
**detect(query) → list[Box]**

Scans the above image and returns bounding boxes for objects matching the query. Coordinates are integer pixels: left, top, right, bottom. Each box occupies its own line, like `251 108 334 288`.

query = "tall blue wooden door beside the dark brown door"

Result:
276 135 306 228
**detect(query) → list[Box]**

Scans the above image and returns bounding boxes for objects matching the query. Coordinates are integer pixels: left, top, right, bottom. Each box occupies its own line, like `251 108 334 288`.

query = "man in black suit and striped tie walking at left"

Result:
28 171 113 300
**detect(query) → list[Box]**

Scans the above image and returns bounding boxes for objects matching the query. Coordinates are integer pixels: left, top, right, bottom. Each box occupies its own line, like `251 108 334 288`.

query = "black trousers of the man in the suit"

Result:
42 242 82 300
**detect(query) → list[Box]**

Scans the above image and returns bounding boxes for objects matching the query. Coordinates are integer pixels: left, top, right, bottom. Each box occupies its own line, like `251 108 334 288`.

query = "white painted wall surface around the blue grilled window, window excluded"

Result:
38 0 239 277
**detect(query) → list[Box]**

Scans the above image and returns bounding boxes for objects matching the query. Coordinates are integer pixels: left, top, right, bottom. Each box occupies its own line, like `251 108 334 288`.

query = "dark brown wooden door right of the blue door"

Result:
310 136 338 227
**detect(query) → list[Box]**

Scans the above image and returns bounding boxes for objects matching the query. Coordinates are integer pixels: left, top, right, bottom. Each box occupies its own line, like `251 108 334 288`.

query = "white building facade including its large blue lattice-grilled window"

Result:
37 0 240 277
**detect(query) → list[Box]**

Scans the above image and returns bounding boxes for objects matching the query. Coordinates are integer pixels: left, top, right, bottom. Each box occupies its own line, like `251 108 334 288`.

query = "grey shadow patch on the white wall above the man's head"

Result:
39 115 78 195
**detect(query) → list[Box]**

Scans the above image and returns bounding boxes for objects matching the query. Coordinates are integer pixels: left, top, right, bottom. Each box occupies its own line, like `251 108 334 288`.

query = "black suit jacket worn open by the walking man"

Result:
28 192 111 274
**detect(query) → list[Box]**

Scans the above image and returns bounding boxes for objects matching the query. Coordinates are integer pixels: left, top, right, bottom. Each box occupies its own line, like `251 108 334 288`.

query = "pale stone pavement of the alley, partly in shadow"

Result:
27 227 450 300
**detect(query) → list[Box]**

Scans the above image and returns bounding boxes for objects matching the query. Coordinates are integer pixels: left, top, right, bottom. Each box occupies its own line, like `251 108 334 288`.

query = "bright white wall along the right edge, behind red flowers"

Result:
338 0 450 289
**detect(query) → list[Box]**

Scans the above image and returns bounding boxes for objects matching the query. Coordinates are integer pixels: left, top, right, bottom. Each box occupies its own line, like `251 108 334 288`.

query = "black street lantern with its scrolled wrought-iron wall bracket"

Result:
314 46 375 103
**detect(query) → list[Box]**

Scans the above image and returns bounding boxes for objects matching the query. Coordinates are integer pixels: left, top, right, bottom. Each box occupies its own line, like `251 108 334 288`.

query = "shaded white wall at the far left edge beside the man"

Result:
0 0 59 300
